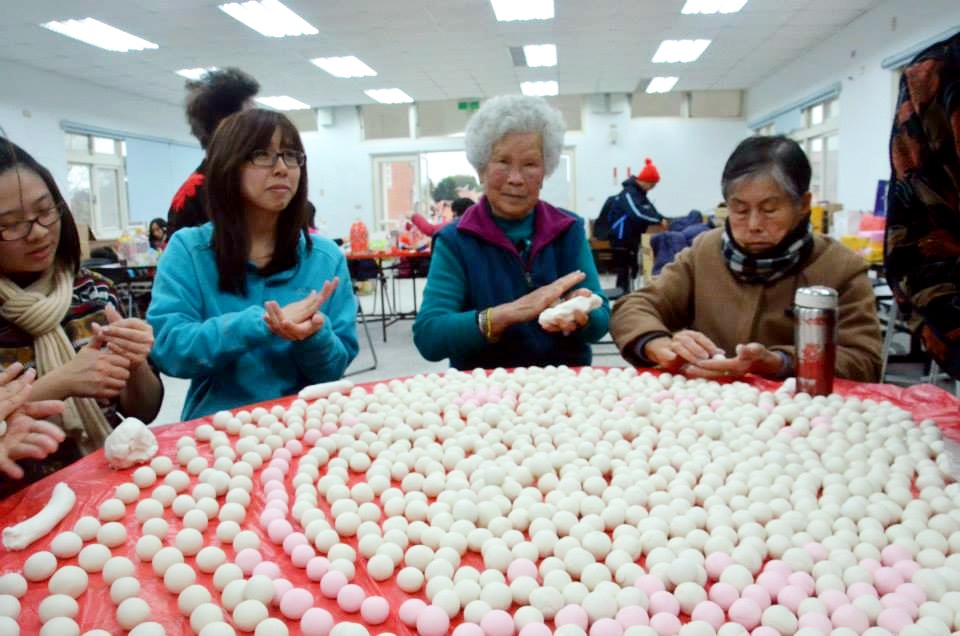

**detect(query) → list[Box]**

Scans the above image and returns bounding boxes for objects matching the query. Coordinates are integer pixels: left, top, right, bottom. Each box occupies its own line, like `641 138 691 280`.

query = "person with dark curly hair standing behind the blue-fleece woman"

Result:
165 68 260 242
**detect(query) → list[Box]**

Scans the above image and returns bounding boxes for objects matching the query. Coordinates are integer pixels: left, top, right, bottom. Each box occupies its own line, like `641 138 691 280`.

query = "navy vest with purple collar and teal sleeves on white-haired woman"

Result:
413 197 610 369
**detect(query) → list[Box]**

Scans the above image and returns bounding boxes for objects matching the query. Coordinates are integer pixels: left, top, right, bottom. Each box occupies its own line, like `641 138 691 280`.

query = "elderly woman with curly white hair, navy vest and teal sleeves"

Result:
413 95 610 369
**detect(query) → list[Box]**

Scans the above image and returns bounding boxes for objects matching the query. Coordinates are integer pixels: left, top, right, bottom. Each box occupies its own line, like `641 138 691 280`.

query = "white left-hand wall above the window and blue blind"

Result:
0 60 197 202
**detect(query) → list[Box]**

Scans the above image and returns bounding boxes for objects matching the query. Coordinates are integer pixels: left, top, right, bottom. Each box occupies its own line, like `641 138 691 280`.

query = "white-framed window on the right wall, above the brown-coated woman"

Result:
790 96 840 202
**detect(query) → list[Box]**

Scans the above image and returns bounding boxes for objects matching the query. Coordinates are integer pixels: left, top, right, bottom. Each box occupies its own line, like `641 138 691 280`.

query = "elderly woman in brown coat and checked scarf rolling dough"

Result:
610 137 881 382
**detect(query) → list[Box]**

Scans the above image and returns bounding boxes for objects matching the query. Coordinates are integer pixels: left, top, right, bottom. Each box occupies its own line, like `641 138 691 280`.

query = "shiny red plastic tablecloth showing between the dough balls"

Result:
0 379 960 635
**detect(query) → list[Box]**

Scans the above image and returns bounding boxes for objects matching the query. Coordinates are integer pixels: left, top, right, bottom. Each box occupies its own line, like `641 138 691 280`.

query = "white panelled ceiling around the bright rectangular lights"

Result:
0 0 881 106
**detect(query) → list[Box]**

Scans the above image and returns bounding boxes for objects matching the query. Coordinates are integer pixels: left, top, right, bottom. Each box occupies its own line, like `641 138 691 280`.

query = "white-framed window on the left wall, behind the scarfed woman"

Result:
65 132 128 239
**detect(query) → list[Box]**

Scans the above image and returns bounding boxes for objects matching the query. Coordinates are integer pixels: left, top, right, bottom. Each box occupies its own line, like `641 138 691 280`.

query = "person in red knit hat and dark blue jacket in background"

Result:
594 157 666 292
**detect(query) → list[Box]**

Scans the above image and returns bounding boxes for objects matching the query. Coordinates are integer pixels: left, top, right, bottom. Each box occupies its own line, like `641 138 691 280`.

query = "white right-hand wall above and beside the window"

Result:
747 0 960 210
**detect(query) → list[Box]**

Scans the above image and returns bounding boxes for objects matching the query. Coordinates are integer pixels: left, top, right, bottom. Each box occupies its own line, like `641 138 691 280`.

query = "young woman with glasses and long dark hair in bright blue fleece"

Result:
147 110 357 420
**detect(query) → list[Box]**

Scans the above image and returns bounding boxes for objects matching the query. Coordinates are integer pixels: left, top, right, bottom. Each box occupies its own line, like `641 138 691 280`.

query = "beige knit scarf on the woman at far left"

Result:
0 268 111 454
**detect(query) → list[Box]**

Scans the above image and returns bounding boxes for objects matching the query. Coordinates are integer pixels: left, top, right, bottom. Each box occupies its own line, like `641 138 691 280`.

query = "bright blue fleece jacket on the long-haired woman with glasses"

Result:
147 223 358 420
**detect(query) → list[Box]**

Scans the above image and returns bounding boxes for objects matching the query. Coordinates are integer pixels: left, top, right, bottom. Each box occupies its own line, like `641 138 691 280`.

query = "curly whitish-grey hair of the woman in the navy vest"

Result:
464 95 566 176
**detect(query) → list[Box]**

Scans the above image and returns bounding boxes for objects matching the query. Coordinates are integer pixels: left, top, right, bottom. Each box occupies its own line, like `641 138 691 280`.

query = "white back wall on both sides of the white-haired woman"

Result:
303 106 750 236
